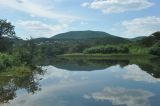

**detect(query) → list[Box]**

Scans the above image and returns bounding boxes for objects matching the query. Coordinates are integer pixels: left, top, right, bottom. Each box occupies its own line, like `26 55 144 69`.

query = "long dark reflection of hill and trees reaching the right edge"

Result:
47 57 160 78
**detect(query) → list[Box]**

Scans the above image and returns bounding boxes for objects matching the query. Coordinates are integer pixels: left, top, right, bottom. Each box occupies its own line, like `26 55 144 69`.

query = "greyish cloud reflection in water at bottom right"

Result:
84 88 154 106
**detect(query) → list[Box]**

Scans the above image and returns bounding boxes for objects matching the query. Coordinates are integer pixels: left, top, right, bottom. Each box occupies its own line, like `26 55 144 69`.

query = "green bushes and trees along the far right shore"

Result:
57 32 160 56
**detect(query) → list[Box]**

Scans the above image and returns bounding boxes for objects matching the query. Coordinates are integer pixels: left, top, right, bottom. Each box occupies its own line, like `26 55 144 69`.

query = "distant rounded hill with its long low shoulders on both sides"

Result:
34 31 130 45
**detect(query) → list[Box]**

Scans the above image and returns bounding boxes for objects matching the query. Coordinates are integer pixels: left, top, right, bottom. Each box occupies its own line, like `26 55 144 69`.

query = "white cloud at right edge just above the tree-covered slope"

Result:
122 16 160 37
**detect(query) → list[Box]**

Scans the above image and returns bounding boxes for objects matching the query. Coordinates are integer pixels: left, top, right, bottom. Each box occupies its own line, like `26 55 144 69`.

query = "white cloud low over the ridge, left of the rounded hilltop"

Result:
17 20 70 38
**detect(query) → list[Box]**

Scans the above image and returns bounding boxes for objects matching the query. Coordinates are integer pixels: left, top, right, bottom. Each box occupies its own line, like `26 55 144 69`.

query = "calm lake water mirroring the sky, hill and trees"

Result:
0 58 160 106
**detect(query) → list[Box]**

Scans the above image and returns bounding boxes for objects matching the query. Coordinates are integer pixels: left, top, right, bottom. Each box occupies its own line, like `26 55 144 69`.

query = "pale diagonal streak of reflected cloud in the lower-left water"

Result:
4 77 92 106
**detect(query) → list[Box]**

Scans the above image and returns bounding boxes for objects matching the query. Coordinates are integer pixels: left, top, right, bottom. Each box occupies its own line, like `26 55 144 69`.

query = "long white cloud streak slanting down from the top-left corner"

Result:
0 0 80 20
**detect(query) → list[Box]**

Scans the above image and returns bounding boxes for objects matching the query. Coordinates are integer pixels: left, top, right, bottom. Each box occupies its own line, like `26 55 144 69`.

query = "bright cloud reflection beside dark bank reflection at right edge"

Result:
122 65 160 83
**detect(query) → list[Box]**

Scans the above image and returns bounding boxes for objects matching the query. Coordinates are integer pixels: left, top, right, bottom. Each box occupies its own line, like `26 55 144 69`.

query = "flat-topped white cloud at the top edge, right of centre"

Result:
82 0 154 14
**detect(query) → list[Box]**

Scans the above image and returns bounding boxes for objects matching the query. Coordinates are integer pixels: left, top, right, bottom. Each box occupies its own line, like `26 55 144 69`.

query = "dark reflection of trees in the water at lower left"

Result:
0 68 44 103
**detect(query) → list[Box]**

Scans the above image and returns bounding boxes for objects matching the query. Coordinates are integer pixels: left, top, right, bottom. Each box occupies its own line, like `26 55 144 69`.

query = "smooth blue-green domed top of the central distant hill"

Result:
52 31 119 39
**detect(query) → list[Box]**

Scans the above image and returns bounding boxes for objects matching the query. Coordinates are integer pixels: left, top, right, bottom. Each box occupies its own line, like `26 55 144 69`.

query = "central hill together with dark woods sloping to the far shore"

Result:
30 31 131 54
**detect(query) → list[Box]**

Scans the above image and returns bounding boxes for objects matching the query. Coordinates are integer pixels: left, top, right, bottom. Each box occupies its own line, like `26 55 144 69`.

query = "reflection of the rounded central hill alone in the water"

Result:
47 58 129 71
